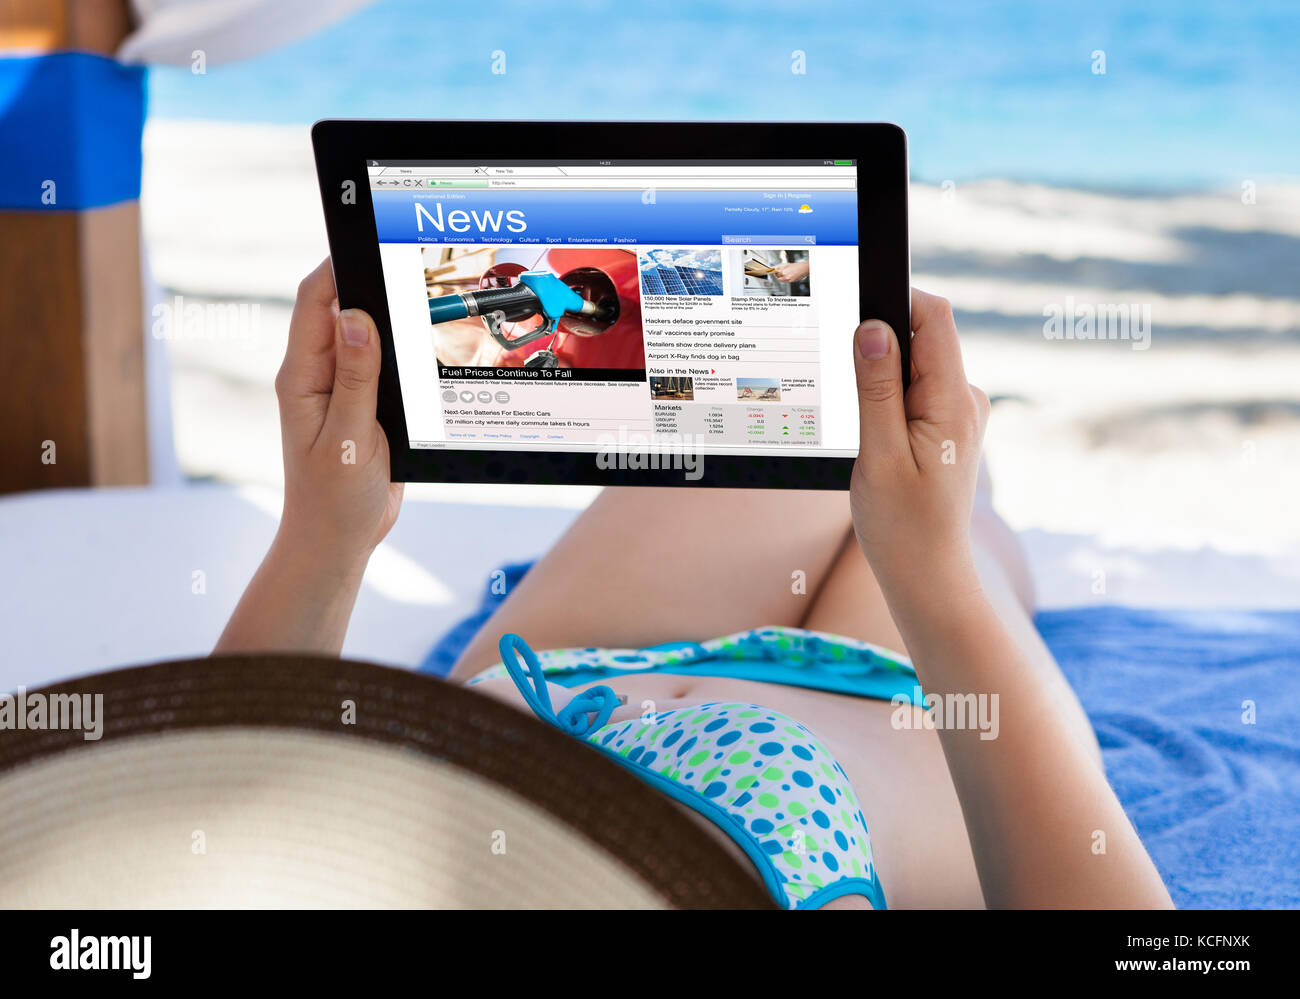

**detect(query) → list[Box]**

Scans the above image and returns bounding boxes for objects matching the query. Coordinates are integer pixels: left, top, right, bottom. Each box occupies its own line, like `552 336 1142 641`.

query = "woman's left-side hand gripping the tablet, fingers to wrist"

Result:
276 260 402 570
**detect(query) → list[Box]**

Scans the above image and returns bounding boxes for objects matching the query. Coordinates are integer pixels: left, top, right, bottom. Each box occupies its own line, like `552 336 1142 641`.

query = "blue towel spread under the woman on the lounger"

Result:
421 563 1300 909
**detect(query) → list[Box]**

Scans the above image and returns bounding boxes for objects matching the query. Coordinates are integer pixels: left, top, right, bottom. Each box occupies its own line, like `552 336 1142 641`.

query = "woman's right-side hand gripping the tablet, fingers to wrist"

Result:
849 284 988 598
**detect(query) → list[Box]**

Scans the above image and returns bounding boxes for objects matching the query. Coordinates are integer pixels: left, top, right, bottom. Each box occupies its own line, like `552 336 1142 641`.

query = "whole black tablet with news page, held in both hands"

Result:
312 121 910 489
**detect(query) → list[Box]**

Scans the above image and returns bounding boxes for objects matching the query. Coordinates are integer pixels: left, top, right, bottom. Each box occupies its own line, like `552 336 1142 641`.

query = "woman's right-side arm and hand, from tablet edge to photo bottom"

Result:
850 291 1170 908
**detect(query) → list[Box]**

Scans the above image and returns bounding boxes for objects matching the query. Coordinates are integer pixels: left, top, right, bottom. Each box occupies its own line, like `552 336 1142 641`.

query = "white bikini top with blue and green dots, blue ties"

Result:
501 635 885 909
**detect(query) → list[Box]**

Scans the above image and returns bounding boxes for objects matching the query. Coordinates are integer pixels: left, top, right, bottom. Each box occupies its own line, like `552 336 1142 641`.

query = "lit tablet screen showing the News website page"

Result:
368 160 858 457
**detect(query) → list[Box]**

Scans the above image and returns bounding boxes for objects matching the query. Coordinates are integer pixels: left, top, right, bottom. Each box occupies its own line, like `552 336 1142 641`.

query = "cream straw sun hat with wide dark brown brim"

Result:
0 656 771 908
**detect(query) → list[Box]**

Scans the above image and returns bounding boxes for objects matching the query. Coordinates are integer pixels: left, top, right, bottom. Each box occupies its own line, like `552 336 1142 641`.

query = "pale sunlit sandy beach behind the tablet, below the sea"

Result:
142 120 1300 556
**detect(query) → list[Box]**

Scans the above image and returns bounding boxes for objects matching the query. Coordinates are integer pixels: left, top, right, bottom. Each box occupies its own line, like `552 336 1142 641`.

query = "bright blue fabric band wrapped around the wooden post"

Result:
0 52 144 211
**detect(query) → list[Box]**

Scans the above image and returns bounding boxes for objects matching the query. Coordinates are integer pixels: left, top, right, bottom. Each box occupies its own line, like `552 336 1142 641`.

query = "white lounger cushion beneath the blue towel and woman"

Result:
0 485 1300 691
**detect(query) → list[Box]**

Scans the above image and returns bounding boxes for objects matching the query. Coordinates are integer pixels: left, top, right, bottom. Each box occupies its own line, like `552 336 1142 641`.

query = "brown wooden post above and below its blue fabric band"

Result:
0 0 150 493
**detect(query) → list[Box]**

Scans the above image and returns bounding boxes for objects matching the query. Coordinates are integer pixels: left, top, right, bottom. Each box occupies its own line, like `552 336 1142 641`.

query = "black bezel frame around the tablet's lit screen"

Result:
312 120 911 489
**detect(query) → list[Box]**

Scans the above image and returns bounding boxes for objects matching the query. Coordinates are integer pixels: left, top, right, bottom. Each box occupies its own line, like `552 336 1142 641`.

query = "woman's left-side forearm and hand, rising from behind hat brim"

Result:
213 260 402 656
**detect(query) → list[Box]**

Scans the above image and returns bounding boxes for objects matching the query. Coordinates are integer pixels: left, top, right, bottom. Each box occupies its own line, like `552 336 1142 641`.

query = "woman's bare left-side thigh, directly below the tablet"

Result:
451 488 850 679
